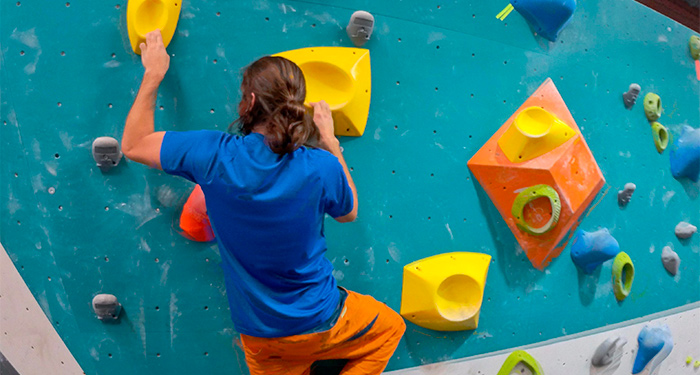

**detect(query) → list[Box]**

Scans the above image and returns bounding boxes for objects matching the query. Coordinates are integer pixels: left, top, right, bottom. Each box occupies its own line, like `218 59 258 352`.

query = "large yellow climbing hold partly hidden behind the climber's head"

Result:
275 47 372 137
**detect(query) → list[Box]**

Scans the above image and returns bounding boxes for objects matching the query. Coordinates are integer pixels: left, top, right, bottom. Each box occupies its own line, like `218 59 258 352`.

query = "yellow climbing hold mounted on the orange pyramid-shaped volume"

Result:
498 107 576 163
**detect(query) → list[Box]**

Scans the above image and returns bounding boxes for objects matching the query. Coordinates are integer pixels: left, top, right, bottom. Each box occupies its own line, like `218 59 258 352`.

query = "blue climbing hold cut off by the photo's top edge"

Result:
510 0 576 42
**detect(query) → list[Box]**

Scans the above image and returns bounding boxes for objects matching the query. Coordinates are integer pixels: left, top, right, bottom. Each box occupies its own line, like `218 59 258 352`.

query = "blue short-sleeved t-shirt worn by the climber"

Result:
160 130 353 337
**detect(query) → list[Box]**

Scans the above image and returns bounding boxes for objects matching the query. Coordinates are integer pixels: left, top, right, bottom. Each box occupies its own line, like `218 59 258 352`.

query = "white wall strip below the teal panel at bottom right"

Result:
387 303 700 375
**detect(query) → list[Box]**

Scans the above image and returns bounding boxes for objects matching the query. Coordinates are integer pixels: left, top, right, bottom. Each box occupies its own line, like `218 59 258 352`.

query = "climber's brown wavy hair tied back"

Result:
231 56 318 154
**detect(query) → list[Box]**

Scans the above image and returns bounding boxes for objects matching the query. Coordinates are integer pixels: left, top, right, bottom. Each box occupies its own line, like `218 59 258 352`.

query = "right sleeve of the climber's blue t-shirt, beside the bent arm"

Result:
324 156 354 218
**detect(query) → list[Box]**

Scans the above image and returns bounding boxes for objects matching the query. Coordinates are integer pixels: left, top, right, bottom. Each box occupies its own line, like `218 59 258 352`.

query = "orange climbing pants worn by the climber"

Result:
241 291 406 375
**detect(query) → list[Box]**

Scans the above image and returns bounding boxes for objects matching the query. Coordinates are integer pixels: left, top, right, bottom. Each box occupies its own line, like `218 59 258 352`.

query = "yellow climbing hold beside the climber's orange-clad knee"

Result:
401 252 491 331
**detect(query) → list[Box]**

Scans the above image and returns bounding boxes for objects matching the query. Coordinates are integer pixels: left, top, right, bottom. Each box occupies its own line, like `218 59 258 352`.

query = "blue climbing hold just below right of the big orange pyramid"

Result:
571 228 620 273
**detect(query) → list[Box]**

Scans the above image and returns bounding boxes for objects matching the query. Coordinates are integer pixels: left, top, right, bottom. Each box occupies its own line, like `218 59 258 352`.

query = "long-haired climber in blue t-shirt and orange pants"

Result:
122 30 406 375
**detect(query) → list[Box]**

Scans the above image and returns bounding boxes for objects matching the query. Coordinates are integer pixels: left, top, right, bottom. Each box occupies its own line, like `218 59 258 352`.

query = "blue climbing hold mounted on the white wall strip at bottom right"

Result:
632 324 673 374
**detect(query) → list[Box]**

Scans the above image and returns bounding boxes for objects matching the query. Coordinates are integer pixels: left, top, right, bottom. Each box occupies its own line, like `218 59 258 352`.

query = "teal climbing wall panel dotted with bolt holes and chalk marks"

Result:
0 0 700 374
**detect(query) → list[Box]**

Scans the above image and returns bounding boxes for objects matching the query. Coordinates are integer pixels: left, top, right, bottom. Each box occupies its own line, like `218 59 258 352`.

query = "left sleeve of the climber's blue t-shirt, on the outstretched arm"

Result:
160 130 227 183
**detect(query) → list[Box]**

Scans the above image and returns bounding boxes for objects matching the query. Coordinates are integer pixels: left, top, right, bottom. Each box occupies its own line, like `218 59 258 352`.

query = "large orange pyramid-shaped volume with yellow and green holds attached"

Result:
467 79 605 270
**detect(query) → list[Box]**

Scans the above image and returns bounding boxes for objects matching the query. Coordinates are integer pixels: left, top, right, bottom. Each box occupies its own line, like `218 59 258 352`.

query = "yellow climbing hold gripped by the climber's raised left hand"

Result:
126 0 182 55
